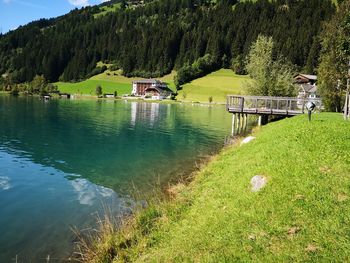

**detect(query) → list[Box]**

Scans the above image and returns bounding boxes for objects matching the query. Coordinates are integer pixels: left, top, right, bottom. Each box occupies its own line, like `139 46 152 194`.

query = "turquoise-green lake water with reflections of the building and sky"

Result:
0 96 231 263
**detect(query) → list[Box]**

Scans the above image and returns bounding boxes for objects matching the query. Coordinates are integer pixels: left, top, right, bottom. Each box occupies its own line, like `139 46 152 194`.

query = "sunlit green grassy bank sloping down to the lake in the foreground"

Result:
84 113 350 262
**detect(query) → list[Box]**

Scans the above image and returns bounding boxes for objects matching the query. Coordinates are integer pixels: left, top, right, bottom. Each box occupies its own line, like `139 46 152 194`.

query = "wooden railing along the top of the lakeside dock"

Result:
227 95 322 115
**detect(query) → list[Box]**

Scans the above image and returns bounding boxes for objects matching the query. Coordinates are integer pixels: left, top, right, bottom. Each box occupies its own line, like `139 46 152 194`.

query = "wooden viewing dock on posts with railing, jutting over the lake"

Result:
226 95 322 135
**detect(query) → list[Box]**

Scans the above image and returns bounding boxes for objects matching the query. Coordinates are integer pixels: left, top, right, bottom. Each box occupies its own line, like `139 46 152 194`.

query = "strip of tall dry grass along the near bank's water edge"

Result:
76 126 254 262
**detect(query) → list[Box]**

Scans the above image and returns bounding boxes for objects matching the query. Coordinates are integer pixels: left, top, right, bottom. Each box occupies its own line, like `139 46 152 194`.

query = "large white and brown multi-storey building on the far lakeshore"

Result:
131 79 173 100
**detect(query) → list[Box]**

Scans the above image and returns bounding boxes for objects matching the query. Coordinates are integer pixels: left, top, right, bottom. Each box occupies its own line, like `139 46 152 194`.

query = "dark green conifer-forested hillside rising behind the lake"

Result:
0 0 335 83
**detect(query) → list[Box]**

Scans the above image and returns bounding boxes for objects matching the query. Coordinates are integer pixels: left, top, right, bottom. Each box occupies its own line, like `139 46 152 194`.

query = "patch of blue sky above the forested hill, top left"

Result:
0 0 106 33
